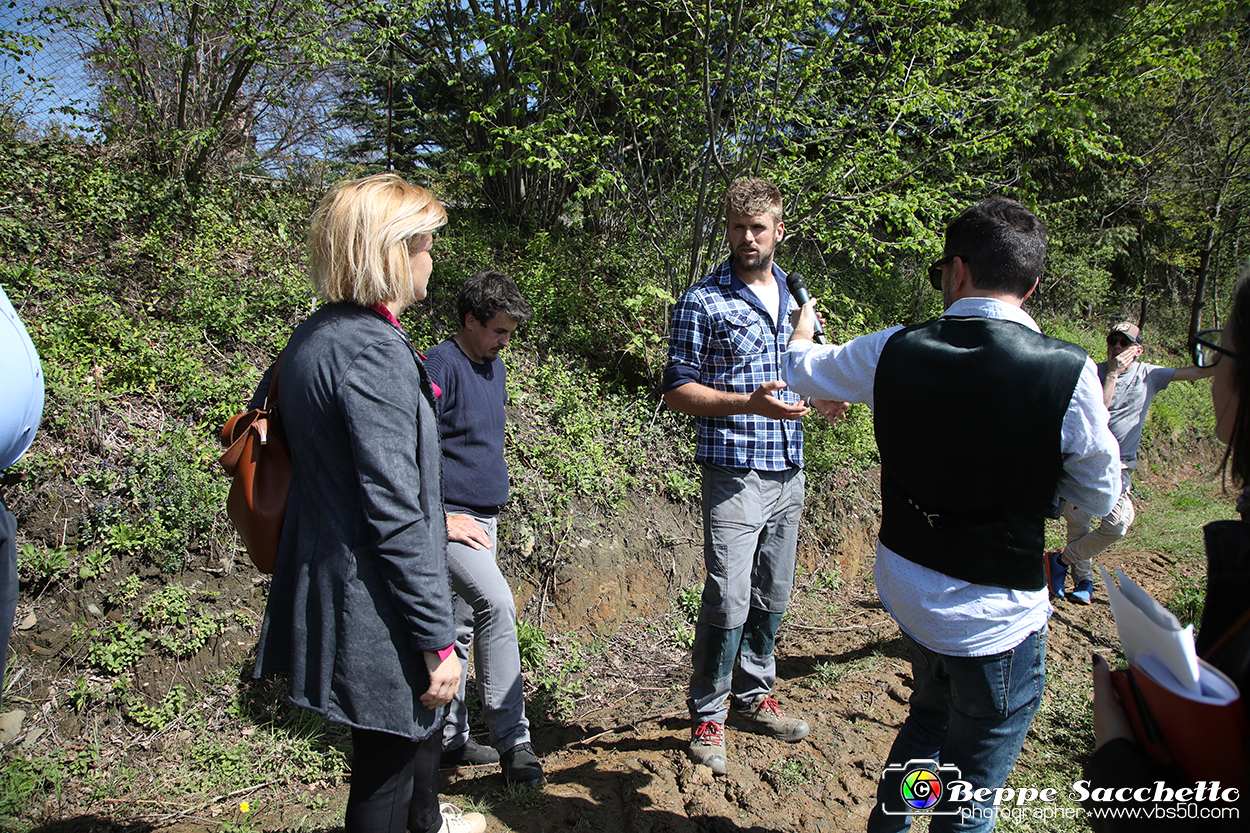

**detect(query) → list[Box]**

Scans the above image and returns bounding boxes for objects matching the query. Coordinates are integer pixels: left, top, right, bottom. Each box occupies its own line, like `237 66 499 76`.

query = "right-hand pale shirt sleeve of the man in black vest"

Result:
1059 359 1120 518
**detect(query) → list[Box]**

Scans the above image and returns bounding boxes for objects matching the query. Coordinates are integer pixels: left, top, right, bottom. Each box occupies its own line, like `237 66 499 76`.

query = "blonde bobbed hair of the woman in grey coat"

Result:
309 174 448 306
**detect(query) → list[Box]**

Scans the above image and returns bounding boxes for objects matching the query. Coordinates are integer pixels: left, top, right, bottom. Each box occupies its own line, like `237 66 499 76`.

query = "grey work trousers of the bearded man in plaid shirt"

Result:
686 464 805 723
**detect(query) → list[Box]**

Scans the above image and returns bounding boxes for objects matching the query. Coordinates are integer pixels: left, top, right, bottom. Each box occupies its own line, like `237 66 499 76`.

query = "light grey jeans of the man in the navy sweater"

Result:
443 512 530 752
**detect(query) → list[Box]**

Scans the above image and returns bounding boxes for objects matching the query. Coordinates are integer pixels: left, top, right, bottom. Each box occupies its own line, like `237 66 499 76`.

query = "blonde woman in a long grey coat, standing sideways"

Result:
254 174 485 833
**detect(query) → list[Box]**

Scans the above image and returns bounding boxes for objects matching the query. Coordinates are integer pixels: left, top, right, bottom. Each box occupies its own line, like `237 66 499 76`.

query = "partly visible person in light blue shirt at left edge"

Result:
0 280 44 694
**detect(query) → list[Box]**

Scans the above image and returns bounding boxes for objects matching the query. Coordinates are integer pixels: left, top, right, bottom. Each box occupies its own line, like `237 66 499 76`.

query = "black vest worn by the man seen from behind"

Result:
874 312 1086 590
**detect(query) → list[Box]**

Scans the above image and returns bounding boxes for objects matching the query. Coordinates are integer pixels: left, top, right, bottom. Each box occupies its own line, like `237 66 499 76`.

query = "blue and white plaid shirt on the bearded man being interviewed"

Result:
664 260 803 472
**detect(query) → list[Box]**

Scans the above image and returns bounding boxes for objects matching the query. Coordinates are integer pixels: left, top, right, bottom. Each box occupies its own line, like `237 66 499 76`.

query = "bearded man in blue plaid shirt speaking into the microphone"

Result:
664 179 809 774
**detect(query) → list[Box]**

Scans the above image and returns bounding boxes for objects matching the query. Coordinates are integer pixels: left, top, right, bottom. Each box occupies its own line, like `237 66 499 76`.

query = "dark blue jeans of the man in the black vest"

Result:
868 628 1046 833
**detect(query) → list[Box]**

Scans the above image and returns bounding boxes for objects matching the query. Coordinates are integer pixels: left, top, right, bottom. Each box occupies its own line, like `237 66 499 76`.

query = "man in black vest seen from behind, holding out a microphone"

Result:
784 198 1120 833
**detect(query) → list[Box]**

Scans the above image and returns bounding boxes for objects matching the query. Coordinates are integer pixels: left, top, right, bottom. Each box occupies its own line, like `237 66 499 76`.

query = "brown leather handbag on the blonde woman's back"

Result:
219 355 291 573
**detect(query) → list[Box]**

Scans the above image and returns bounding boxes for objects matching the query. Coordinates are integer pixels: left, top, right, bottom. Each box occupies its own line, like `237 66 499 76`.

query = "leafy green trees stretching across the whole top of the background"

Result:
24 0 1246 323
